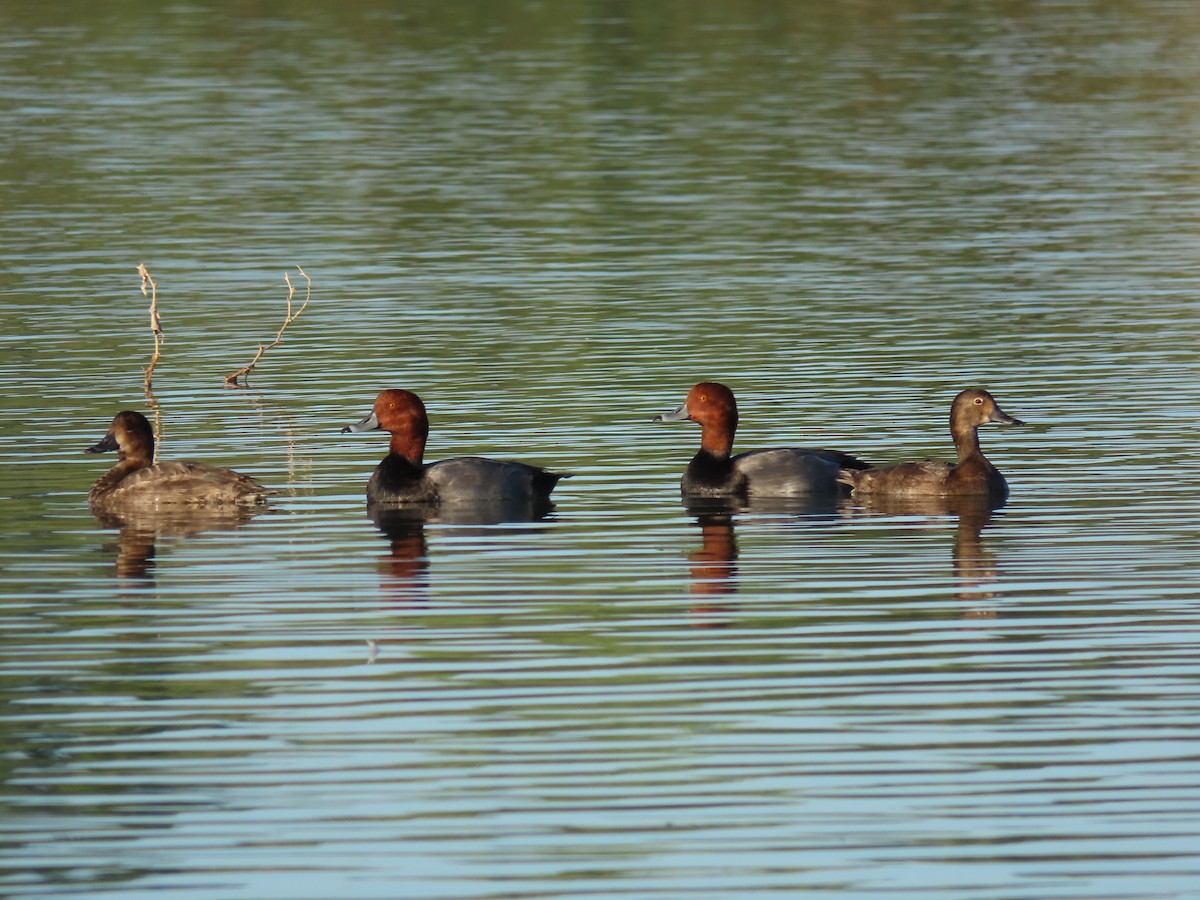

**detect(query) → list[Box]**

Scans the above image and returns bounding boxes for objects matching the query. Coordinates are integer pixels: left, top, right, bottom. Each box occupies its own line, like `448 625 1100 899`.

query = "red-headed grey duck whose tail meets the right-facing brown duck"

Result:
654 382 868 499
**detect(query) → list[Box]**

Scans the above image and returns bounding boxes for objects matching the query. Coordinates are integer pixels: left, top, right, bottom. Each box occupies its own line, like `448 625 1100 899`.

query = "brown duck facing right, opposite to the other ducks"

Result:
839 388 1025 500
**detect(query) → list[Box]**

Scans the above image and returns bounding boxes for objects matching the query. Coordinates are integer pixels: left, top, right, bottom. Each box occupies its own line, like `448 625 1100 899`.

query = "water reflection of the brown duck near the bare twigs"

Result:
94 506 264 581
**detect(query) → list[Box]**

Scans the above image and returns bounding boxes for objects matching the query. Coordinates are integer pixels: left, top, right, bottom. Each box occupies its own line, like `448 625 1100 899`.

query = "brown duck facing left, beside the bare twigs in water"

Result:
84 409 270 516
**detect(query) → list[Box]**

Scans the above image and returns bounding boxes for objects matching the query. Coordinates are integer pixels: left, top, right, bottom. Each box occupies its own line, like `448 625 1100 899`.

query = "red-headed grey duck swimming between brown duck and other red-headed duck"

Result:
342 389 570 508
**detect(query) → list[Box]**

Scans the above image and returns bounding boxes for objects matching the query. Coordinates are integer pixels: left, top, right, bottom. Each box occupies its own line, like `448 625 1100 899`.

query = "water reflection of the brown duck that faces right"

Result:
856 494 1004 618
